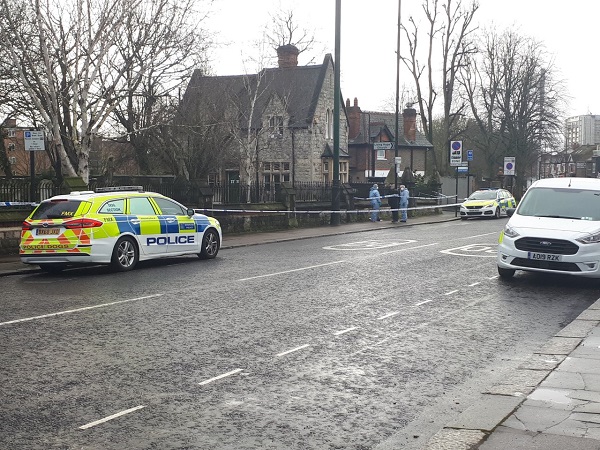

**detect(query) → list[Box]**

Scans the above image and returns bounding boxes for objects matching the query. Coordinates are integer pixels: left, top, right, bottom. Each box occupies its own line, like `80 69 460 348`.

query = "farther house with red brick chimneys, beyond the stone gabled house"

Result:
346 98 433 182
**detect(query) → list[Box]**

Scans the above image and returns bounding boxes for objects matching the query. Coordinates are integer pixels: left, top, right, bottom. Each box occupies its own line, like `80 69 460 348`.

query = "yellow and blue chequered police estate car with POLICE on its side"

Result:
19 186 222 272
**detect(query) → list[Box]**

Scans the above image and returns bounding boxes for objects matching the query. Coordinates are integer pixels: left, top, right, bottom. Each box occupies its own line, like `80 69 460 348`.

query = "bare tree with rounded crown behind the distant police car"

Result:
461 30 564 194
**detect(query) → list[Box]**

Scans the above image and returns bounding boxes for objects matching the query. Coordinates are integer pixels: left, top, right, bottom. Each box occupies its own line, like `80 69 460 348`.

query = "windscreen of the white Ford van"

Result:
517 188 600 220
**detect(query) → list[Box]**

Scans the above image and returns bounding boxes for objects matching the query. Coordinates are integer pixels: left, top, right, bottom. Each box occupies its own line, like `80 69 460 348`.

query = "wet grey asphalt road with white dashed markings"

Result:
0 219 599 450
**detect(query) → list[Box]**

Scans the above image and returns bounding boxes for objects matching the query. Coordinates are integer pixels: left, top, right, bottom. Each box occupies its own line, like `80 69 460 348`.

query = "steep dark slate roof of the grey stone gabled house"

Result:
183 54 333 128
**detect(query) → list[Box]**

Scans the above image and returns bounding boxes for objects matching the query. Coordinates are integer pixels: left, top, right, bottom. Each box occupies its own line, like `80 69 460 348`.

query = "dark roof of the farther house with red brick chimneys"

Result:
350 111 433 148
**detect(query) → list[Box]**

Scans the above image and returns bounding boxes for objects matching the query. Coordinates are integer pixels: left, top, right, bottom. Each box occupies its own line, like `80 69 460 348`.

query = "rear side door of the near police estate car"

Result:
127 197 168 256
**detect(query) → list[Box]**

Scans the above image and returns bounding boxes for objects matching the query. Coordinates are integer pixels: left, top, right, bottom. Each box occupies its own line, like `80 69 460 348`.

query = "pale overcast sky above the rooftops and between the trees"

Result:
206 0 600 117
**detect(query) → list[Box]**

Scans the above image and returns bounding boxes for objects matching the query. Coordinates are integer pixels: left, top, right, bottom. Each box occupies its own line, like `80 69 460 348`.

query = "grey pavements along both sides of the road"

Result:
0 211 600 450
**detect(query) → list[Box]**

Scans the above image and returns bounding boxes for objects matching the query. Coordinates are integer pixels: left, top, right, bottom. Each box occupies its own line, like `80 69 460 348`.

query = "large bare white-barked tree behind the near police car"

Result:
0 0 213 182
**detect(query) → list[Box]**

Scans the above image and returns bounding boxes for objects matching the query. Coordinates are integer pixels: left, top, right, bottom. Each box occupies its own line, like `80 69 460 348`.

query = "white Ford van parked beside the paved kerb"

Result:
496 178 600 278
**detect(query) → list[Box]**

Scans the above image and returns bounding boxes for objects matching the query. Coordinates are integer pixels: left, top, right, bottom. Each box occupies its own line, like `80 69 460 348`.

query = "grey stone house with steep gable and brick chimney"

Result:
182 45 349 185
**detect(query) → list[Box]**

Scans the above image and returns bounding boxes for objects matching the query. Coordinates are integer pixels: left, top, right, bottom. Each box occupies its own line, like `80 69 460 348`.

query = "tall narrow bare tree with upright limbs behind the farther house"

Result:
401 0 479 174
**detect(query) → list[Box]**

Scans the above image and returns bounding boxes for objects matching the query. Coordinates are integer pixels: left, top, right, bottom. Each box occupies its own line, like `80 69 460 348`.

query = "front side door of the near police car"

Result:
152 197 200 253
